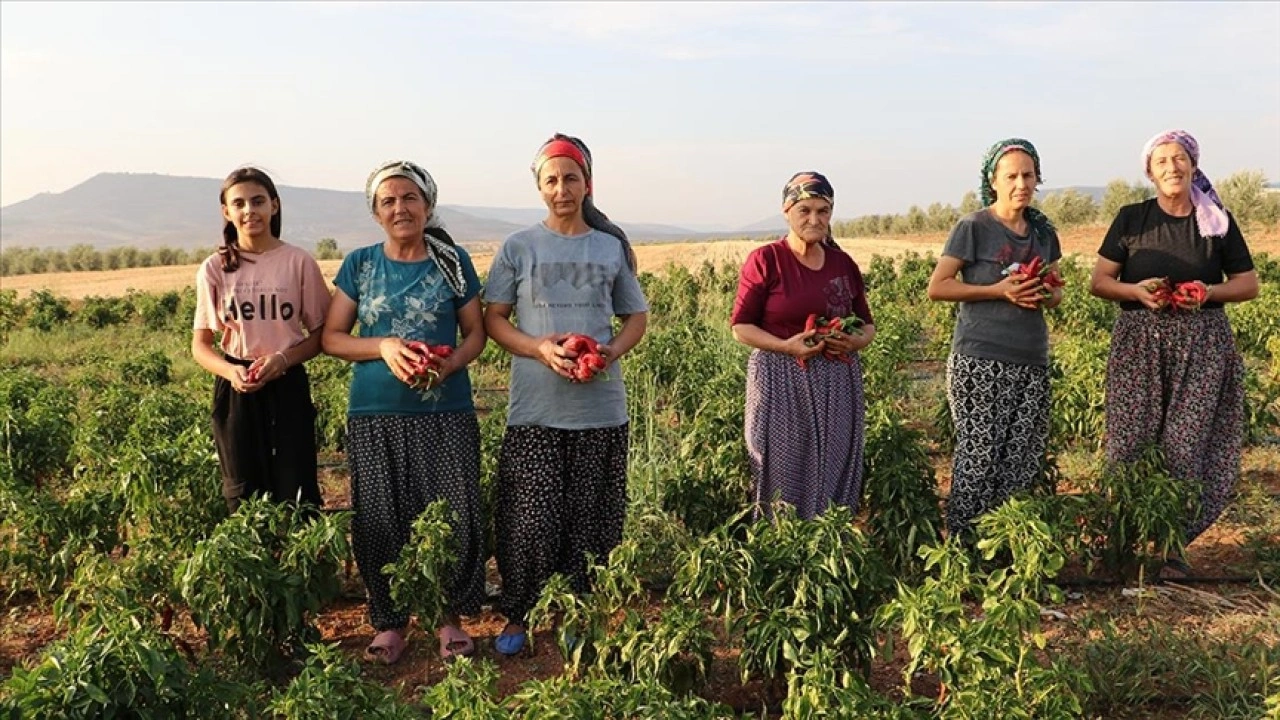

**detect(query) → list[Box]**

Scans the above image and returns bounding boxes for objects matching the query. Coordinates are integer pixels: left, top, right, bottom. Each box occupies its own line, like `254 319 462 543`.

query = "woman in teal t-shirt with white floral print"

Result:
323 161 485 664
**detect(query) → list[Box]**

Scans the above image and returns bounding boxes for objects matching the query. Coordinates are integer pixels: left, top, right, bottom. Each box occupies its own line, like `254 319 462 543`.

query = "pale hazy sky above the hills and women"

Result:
0 0 1280 227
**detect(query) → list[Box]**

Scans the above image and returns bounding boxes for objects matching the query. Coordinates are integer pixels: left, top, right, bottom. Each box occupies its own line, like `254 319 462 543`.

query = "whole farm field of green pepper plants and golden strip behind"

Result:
0 228 1280 719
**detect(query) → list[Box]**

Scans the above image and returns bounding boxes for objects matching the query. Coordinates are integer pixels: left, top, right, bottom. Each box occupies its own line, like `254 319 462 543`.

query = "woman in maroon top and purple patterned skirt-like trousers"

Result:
731 173 876 519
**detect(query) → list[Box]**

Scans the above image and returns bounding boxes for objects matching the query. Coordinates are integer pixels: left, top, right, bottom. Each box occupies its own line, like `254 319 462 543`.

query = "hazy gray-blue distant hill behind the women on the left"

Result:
0 173 768 251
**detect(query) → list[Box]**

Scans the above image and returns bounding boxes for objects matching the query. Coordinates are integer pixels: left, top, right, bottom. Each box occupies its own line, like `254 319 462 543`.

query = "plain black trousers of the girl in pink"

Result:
212 356 323 511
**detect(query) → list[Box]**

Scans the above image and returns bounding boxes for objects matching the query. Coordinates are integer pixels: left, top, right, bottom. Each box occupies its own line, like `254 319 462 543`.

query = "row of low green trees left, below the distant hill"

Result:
0 237 342 277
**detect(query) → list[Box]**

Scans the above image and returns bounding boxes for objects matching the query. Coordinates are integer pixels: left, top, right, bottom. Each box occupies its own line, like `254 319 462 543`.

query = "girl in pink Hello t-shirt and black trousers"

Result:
191 168 330 511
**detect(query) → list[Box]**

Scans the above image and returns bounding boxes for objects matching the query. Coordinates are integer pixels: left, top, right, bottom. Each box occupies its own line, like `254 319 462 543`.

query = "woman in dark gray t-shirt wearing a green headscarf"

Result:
928 138 1062 536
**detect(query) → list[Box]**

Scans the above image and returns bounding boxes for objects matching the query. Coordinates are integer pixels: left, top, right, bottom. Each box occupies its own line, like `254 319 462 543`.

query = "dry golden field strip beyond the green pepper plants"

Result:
0 227 1280 300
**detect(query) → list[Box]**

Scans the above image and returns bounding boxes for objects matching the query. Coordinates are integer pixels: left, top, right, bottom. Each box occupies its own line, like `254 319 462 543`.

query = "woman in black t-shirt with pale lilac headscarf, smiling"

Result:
1089 131 1258 577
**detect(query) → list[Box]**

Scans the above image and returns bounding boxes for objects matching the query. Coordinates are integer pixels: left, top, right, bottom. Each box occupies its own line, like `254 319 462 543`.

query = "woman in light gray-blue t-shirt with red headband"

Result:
484 133 649 655
